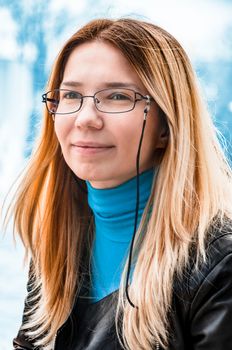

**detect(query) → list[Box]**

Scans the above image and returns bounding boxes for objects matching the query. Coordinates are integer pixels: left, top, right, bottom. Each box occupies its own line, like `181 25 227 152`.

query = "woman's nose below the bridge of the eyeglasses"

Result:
75 96 104 129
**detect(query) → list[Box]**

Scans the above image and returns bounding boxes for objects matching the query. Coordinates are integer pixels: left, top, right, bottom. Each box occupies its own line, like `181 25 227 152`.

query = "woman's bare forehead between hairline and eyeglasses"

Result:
60 41 143 88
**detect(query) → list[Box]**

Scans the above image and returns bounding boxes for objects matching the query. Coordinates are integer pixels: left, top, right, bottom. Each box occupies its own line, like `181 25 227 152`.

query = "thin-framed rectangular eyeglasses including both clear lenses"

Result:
42 88 152 114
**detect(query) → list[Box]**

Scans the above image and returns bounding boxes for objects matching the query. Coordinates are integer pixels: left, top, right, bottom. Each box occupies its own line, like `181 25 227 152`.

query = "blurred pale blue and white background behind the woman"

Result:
0 0 232 350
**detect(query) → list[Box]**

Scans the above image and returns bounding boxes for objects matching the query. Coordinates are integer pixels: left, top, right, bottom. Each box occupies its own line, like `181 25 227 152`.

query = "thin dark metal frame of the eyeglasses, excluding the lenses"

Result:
42 87 154 115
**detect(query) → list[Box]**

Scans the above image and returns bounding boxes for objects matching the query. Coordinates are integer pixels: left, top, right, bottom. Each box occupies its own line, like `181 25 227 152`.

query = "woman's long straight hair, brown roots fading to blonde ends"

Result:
6 19 232 350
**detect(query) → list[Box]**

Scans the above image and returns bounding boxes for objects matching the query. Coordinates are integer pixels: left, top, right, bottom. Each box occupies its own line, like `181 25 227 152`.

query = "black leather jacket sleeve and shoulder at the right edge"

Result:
171 220 232 349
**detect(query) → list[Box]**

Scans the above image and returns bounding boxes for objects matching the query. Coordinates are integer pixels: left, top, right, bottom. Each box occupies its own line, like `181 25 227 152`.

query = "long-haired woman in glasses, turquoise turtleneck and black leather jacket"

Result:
11 19 232 350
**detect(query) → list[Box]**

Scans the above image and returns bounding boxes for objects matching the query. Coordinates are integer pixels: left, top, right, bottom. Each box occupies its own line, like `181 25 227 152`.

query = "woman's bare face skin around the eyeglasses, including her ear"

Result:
55 41 164 188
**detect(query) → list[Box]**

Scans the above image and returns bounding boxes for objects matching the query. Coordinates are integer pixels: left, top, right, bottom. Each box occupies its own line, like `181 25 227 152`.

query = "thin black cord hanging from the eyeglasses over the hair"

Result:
126 116 147 309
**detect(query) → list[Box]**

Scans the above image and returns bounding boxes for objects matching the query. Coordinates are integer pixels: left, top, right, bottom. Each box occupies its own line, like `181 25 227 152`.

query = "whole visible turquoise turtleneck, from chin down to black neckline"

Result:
87 169 154 302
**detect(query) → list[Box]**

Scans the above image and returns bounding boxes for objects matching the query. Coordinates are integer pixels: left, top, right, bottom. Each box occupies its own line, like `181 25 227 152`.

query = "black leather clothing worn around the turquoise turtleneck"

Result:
14 225 232 350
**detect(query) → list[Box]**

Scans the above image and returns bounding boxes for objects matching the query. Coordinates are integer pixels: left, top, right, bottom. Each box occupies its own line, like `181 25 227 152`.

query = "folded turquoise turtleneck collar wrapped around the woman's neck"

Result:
87 169 154 243
